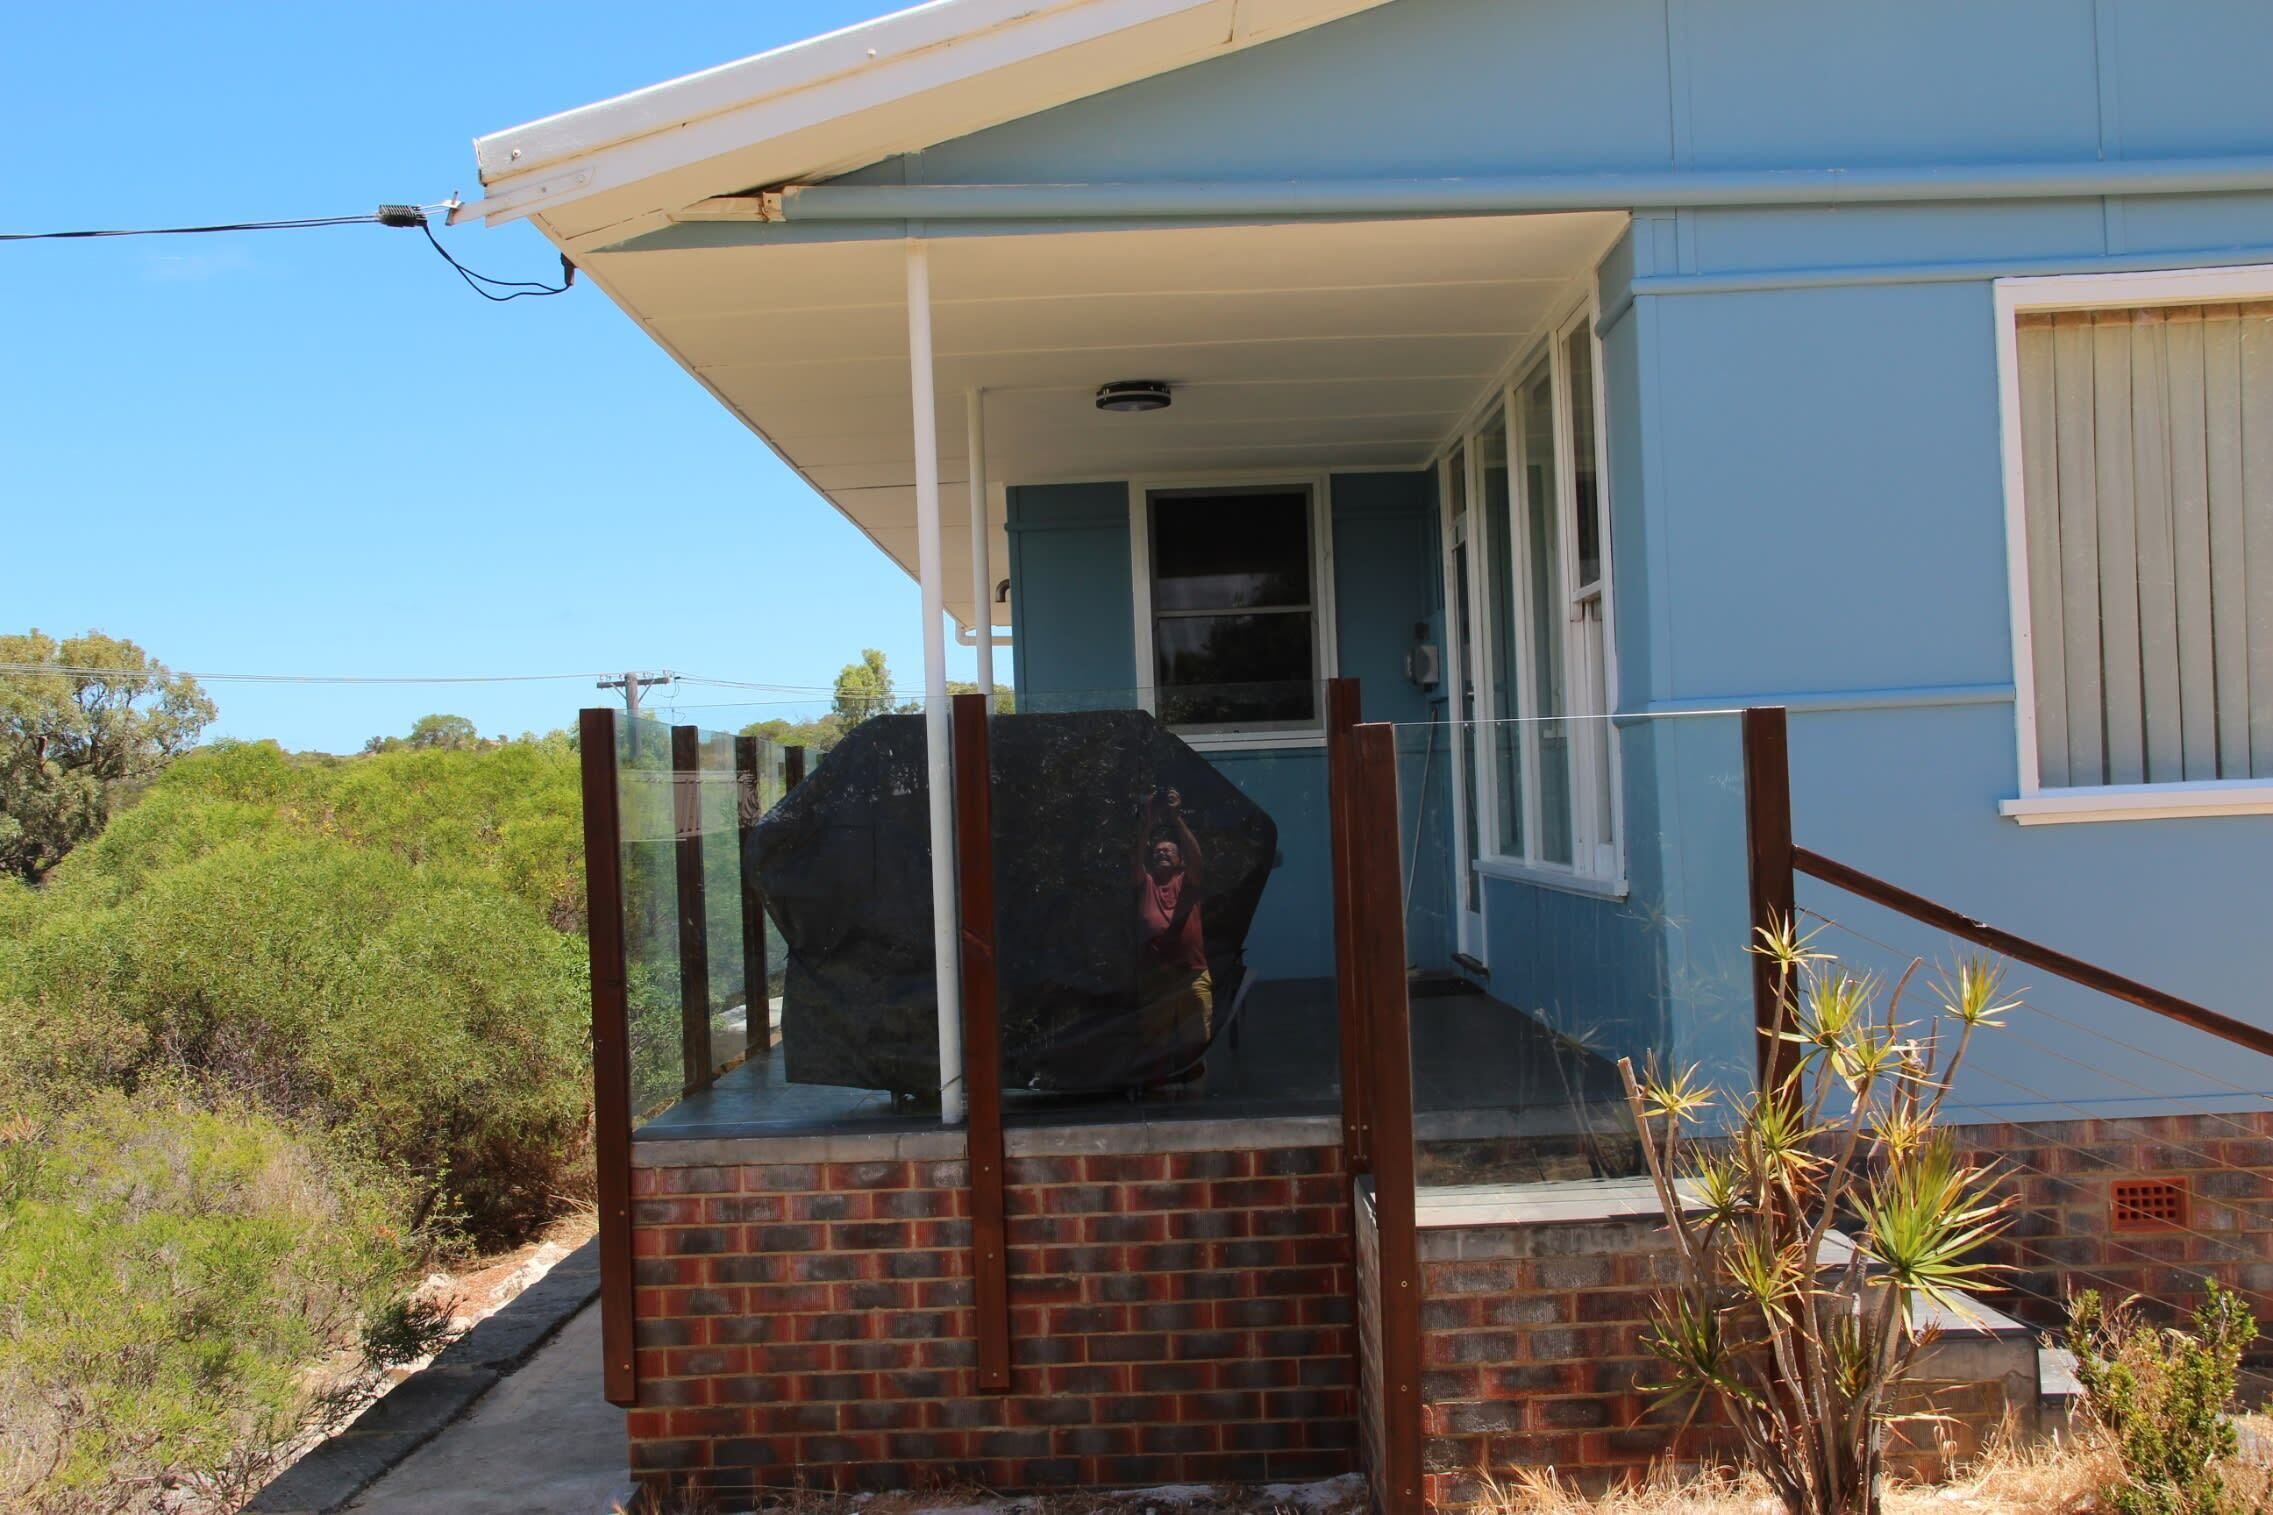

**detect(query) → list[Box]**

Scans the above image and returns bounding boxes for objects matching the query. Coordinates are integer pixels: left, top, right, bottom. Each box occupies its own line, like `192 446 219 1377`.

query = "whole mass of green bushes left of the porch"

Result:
0 736 591 1510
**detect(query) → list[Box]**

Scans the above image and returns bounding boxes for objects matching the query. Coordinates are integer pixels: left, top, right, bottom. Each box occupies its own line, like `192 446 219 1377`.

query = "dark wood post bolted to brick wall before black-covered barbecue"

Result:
952 695 1009 1392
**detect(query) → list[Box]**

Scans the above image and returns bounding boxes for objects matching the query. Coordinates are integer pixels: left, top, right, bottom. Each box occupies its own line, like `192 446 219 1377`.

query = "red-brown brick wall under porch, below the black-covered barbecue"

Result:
630 1136 1357 1488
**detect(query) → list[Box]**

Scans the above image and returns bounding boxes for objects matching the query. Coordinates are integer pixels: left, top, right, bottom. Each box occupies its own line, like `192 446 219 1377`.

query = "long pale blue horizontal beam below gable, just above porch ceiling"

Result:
766 154 2273 220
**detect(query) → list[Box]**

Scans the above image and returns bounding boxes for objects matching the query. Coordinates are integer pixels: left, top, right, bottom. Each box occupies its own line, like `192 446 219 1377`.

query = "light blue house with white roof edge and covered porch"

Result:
461 0 2273 1135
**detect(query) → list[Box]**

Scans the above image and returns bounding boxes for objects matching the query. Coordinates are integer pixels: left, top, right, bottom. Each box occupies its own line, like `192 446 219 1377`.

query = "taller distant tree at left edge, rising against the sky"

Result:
0 627 216 884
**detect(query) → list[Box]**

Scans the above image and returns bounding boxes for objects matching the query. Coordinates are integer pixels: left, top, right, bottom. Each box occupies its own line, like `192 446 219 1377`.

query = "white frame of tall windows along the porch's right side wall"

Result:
1437 288 1627 899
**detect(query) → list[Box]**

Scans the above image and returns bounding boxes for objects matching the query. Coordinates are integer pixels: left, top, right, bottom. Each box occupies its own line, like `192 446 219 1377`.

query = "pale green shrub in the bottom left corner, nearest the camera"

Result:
0 1090 434 1515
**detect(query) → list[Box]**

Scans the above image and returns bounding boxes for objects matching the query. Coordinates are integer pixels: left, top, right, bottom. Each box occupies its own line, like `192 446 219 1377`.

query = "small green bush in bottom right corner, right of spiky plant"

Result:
2068 1279 2257 1515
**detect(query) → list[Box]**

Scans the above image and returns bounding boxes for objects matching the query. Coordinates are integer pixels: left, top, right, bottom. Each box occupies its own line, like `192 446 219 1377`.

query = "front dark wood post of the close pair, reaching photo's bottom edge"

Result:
1350 725 1423 1515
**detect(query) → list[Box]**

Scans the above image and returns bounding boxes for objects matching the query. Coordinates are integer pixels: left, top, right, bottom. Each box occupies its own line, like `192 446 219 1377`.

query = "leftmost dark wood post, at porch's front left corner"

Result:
577 711 639 1404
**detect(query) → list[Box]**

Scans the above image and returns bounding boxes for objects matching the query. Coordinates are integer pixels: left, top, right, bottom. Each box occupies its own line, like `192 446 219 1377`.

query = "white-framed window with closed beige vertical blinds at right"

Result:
1998 270 2273 820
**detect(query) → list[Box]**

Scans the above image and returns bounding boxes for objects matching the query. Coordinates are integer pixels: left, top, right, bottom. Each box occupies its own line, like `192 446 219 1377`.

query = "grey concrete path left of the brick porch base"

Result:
345 1304 630 1515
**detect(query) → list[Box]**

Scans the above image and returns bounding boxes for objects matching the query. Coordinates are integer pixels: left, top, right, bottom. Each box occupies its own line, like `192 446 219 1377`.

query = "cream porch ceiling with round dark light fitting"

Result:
580 214 1625 627
